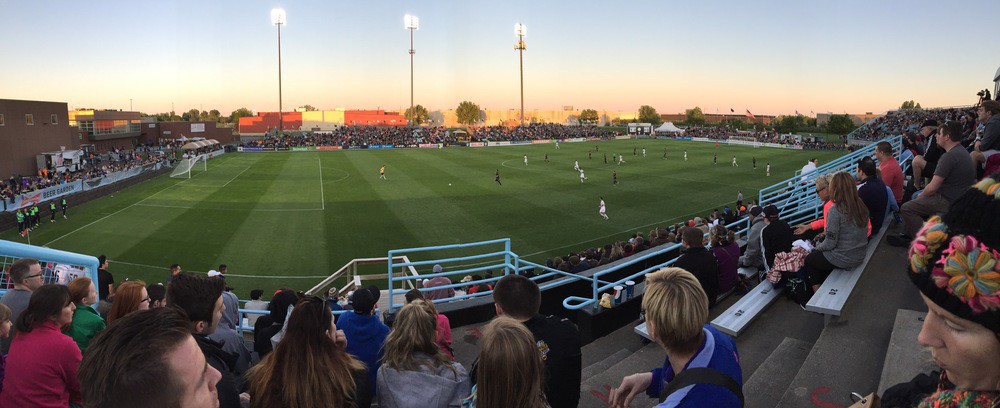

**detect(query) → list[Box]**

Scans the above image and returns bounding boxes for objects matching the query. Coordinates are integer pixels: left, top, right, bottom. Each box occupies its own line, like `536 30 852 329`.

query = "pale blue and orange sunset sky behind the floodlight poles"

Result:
0 0 1000 114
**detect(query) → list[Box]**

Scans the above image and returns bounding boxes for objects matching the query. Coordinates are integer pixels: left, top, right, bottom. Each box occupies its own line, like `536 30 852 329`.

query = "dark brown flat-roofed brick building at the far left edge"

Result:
0 99 81 178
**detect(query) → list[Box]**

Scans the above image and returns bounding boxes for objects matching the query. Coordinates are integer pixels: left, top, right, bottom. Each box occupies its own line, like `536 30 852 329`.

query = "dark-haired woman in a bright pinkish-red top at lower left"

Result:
0 285 83 408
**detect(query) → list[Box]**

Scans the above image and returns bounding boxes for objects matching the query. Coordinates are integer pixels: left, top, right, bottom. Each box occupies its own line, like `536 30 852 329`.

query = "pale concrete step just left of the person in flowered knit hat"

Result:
878 309 940 395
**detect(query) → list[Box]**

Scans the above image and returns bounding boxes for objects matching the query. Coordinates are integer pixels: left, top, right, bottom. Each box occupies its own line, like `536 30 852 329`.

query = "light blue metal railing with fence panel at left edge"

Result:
0 240 100 295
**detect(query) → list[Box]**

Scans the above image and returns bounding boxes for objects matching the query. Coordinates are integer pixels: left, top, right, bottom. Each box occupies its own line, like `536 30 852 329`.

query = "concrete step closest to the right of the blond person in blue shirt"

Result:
743 337 812 408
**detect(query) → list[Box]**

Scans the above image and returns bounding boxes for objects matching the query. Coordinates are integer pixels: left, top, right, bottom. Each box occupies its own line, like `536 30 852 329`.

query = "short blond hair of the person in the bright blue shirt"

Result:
642 267 708 353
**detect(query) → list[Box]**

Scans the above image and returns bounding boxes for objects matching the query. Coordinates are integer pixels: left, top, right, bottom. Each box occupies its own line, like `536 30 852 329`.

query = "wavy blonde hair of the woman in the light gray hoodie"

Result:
382 299 458 375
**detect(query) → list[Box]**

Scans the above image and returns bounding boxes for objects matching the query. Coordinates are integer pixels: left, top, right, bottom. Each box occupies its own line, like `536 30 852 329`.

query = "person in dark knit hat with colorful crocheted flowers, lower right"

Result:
909 174 1000 407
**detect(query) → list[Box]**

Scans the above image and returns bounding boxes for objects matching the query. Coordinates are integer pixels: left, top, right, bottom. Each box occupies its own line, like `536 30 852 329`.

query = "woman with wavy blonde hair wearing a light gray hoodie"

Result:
375 299 471 408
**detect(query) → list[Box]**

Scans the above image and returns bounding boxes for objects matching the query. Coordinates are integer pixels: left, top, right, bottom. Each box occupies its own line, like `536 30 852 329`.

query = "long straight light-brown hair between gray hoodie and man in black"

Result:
475 316 549 408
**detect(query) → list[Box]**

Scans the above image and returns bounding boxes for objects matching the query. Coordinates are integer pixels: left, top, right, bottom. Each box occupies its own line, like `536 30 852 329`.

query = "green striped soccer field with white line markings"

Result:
0 140 841 298
